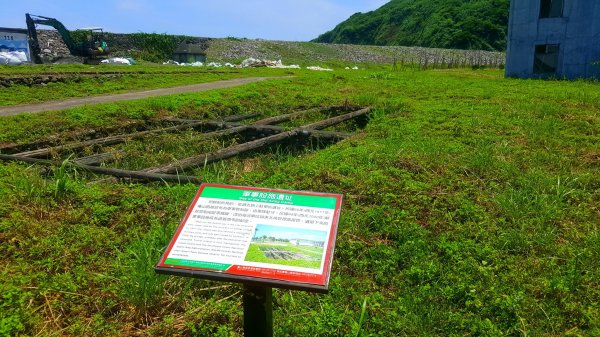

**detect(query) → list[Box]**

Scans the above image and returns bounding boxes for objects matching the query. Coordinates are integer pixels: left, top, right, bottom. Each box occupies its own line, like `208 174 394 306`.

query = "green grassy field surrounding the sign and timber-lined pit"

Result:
0 61 600 336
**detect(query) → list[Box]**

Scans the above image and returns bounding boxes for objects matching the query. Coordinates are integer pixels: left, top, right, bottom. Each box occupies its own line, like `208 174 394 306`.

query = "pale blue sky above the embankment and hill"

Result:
0 0 389 41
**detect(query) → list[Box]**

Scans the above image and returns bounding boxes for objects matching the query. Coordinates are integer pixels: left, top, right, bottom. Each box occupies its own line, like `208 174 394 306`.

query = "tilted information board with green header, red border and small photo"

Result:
155 184 342 292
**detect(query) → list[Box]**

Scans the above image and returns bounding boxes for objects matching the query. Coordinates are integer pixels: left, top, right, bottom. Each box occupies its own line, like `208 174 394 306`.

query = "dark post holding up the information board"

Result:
243 284 273 337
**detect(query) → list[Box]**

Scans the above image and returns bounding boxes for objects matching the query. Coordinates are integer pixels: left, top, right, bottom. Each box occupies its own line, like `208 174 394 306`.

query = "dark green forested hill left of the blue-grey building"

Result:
314 0 510 51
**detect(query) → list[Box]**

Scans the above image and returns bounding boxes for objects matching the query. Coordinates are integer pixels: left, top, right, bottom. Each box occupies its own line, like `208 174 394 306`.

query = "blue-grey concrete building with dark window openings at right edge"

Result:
506 0 600 79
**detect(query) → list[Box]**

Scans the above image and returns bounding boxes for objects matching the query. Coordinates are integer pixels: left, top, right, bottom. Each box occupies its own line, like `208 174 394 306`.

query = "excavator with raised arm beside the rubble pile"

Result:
25 13 109 63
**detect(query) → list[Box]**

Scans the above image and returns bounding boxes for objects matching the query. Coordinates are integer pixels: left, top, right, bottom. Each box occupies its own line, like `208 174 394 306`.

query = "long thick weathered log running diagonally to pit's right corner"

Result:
144 108 370 173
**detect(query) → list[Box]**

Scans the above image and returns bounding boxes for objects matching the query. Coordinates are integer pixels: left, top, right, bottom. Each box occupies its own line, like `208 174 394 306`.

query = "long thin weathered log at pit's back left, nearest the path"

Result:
17 115 253 157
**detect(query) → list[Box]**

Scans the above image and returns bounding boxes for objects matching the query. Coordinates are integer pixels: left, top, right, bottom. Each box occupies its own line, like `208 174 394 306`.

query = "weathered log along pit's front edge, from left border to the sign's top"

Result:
0 154 202 184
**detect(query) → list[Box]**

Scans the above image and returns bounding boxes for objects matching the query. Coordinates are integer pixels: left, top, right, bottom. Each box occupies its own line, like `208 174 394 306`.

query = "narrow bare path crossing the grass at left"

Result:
0 77 286 117
